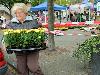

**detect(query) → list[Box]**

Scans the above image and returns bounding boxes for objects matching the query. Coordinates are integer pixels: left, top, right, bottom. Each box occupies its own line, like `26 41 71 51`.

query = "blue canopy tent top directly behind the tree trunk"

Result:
30 2 67 11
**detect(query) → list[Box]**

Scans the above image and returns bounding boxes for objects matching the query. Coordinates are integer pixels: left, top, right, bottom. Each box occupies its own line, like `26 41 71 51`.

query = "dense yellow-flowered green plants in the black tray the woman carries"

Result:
4 28 46 49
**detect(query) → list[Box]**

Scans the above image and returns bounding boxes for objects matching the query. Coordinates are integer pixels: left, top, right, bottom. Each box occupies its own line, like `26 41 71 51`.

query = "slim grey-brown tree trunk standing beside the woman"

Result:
48 0 55 50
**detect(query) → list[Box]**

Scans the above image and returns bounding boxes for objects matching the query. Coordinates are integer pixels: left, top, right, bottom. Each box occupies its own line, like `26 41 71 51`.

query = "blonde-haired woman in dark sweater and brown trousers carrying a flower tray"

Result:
7 3 43 75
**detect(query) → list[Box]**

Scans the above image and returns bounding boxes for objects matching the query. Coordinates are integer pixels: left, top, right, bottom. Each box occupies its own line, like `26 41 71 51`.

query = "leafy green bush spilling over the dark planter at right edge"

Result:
74 36 100 61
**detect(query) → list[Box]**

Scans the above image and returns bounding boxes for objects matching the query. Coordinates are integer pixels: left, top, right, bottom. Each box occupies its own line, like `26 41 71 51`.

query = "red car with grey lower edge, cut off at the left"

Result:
0 48 8 75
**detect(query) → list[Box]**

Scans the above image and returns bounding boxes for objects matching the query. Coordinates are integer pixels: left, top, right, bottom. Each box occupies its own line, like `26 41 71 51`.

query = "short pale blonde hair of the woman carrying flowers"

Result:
11 3 28 16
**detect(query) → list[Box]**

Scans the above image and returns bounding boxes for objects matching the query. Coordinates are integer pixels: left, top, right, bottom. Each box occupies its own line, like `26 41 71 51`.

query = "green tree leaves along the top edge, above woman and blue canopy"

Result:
0 0 81 10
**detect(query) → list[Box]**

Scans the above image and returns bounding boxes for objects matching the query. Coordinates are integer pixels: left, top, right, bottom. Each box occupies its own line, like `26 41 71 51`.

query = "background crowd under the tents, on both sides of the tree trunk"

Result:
30 10 96 23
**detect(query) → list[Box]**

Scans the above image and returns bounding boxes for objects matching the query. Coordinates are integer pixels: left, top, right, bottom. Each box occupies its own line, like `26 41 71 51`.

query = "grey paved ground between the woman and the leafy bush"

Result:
0 29 91 75
